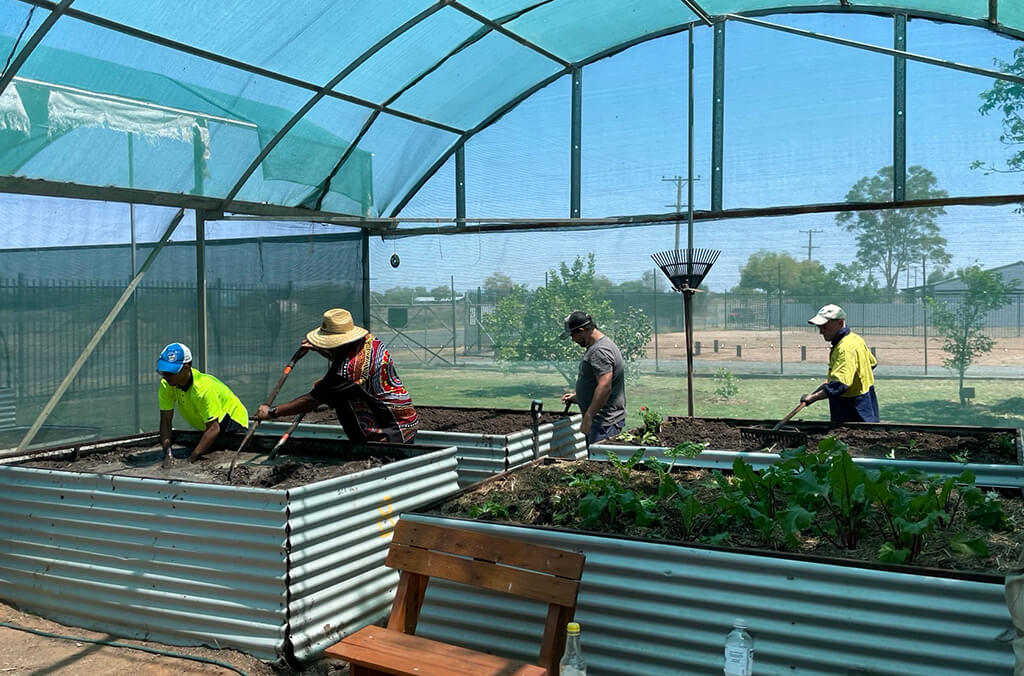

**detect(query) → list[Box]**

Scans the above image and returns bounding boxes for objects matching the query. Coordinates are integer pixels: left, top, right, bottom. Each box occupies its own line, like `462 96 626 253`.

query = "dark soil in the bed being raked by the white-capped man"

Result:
602 417 1017 464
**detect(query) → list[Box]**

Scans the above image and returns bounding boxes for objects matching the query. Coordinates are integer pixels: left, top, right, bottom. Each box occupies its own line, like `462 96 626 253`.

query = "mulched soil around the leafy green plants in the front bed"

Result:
432 459 1024 575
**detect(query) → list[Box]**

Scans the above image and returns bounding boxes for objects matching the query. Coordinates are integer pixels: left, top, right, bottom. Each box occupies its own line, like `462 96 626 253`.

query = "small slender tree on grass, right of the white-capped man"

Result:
928 265 1017 406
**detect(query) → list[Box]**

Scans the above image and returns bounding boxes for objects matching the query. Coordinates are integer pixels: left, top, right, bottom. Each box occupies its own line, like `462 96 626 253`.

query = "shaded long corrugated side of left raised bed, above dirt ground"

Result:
0 466 287 660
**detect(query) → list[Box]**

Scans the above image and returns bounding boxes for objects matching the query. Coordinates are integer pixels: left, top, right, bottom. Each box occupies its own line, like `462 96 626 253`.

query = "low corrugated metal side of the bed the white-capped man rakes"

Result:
590 443 1024 489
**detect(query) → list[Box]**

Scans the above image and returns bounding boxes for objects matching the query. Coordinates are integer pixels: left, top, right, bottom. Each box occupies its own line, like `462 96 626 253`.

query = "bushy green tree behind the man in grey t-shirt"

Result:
482 253 651 384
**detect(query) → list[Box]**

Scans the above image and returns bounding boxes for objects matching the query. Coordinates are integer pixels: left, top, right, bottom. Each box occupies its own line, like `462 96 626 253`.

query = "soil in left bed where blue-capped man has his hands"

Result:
17 445 393 490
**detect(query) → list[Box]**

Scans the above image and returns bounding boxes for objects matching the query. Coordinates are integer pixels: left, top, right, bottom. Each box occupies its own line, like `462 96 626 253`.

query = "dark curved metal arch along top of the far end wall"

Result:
389 0 1024 218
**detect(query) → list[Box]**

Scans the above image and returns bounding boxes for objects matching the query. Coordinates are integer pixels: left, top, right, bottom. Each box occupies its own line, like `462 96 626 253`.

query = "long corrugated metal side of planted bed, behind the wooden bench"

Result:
403 514 1014 676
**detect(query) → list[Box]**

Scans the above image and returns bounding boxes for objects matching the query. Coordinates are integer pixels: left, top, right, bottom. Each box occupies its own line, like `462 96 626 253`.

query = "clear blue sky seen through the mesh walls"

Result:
6 9 1024 290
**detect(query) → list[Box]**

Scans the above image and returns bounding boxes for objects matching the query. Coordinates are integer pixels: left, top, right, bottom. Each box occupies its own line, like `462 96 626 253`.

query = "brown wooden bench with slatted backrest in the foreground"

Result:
326 519 584 676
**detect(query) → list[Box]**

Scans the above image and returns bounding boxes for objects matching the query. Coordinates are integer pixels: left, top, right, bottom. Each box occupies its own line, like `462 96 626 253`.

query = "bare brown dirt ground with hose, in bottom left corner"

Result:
0 603 348 676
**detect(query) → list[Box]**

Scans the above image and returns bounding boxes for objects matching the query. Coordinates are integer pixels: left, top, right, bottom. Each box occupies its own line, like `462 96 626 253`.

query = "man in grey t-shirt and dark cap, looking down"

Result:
560 311 626 445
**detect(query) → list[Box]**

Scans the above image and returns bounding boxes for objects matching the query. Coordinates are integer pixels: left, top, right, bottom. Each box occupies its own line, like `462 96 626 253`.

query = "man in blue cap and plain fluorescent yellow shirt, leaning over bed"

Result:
157 343 249 465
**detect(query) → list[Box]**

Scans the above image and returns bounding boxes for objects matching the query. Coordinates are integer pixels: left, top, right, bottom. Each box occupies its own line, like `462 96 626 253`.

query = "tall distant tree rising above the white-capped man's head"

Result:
836 166 950 301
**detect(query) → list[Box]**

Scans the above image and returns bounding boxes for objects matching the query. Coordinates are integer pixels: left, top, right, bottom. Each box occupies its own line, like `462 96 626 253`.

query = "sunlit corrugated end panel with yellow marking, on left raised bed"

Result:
288 447 459 661
